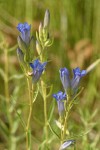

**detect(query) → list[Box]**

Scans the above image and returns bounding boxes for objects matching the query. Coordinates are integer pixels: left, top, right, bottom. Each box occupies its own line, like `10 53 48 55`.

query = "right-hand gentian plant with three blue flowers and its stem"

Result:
53 67 86 150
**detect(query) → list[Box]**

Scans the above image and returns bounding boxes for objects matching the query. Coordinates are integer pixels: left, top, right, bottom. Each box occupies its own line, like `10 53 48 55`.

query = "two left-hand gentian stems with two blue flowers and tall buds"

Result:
17 10 52 150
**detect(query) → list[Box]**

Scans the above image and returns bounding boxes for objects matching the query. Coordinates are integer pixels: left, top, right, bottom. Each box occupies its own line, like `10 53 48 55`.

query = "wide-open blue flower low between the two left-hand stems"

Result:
30 59 47 83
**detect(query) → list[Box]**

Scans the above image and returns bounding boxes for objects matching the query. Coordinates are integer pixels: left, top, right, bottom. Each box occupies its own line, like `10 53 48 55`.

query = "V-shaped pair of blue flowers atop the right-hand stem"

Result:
59 67 86 93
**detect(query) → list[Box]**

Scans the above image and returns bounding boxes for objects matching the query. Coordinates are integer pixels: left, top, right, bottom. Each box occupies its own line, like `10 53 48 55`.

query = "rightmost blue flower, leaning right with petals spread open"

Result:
71 67 86 90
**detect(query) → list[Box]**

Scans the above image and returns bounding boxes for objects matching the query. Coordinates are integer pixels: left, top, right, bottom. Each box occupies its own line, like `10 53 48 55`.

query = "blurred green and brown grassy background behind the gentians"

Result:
0 0 100 150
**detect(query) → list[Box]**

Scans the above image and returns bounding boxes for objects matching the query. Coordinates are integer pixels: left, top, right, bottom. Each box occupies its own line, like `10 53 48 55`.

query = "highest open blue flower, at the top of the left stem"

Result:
17 22 31 44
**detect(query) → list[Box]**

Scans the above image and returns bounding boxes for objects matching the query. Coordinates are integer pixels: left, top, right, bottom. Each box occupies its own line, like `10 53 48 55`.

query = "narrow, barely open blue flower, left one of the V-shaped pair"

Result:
59 68 71 92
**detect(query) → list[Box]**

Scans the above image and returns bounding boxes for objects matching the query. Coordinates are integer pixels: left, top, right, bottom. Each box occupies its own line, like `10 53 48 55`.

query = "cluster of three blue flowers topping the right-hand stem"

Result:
53 67 86 114
